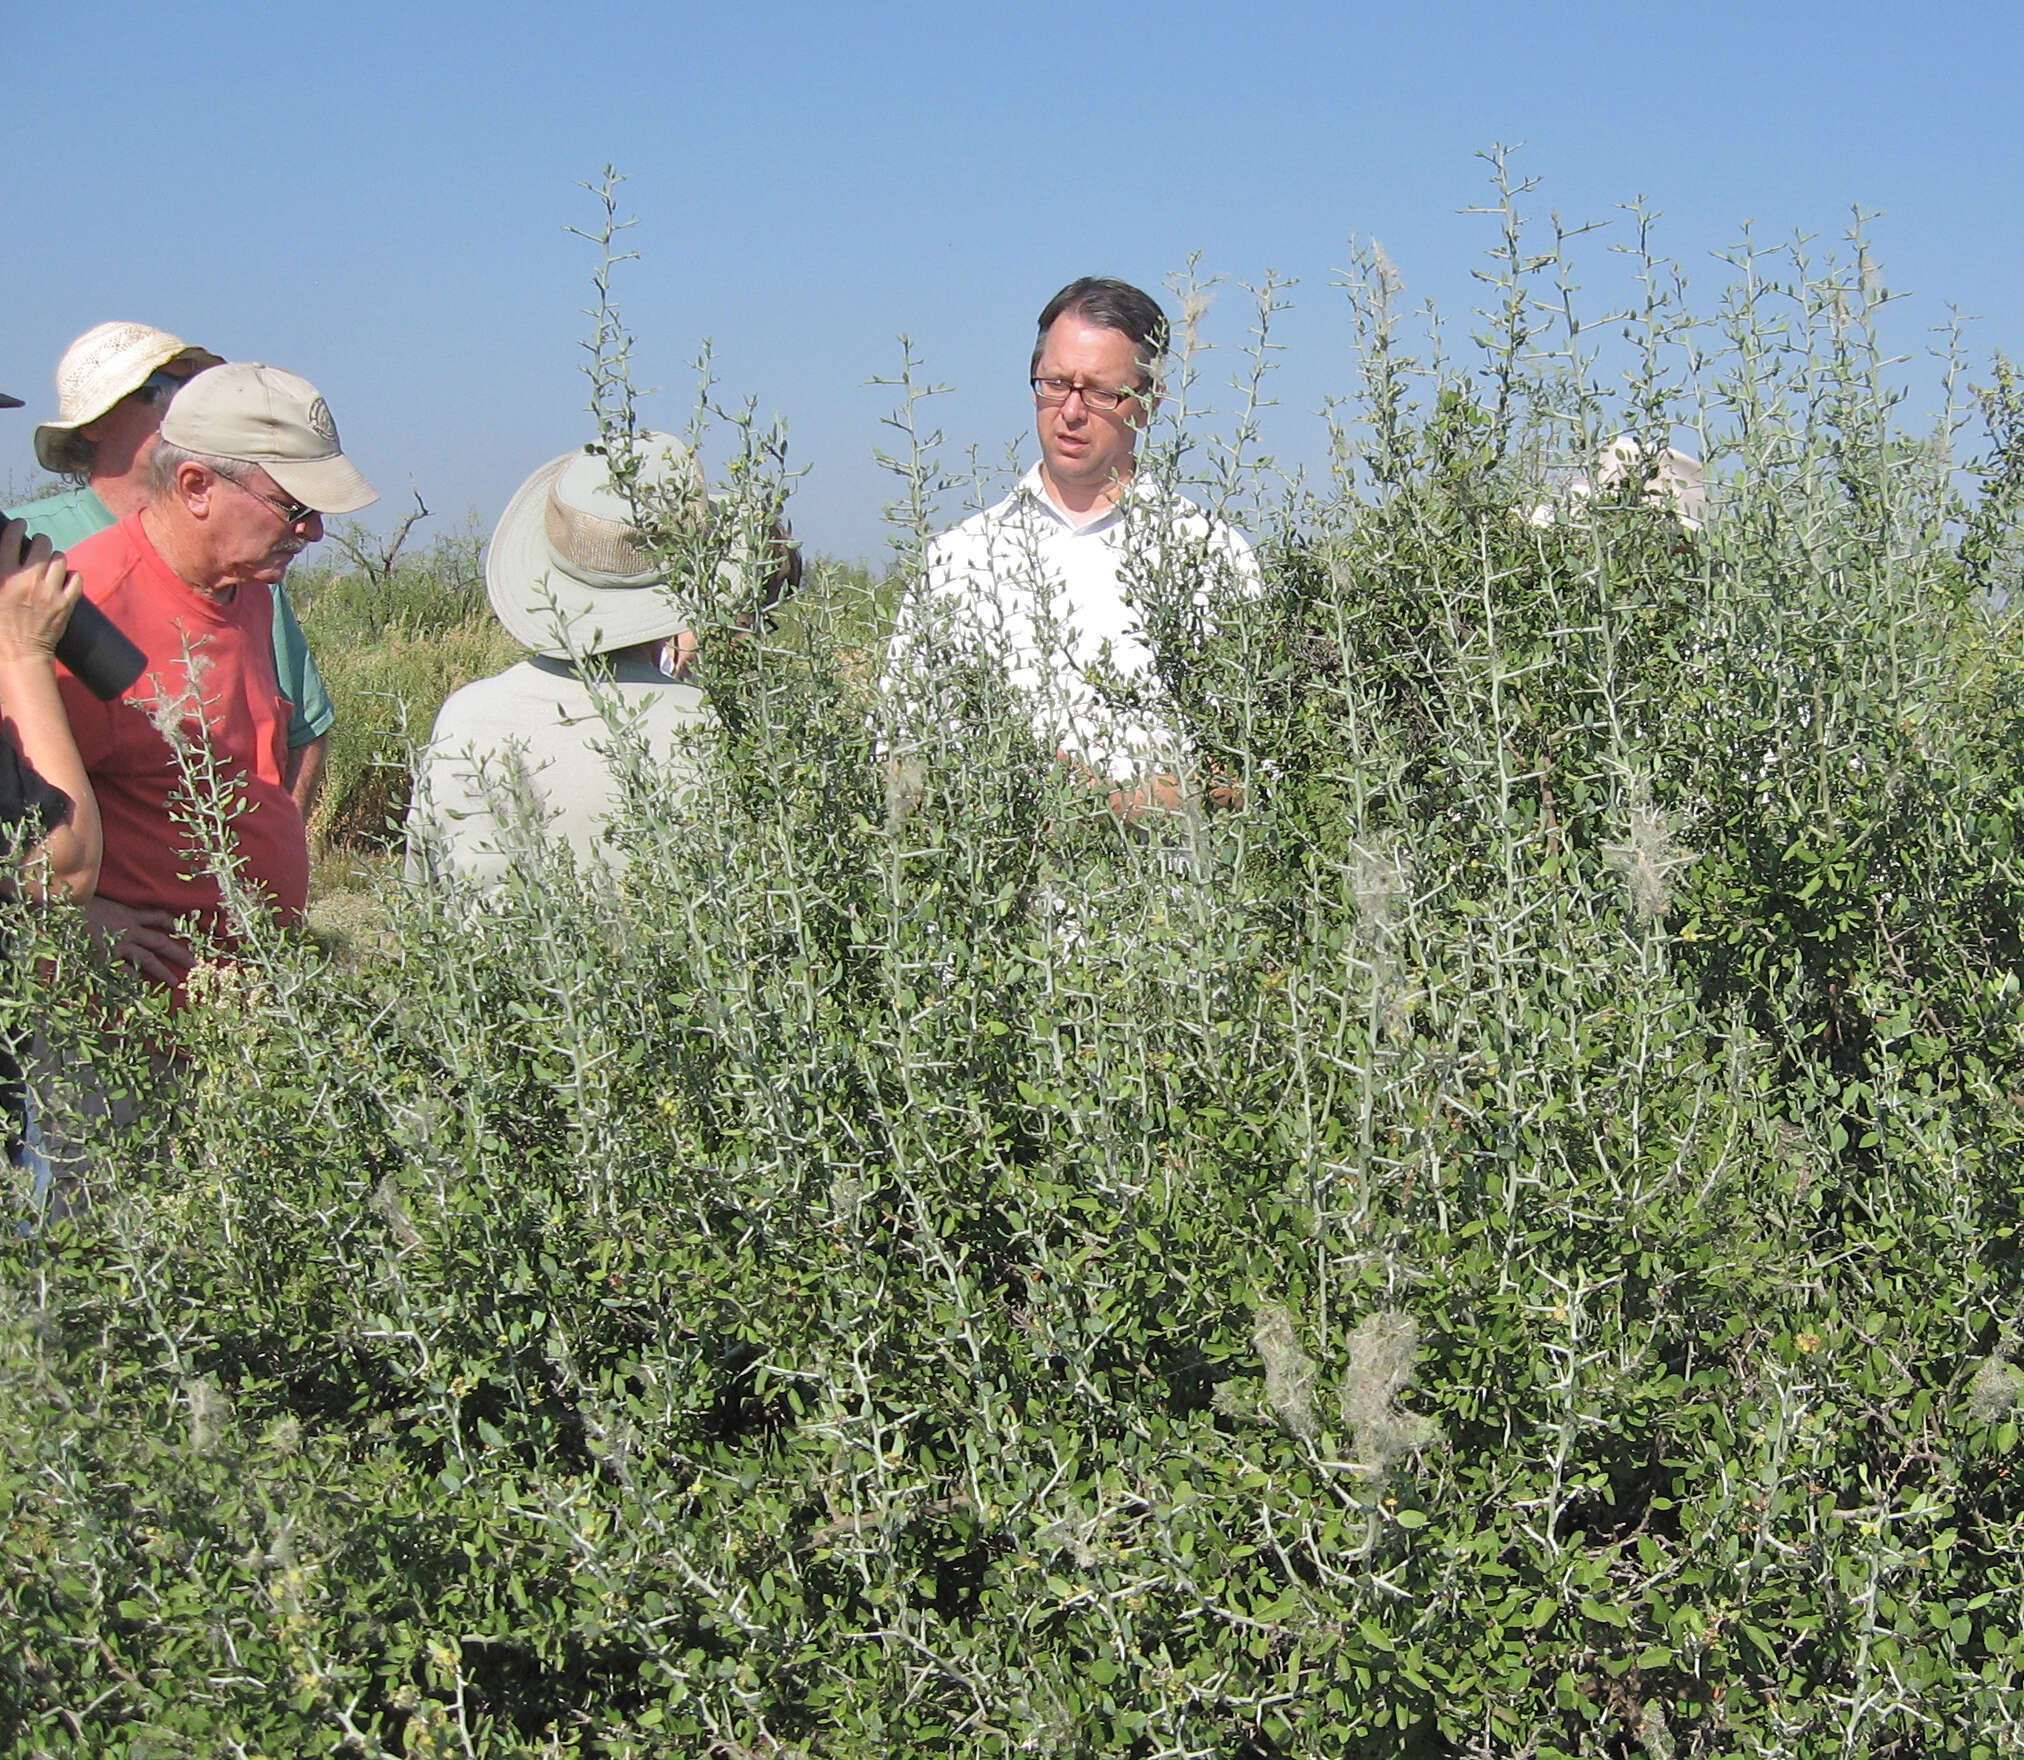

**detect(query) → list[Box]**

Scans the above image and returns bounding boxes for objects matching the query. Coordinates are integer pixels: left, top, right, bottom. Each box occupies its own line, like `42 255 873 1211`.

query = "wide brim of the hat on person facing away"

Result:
486 447 688 659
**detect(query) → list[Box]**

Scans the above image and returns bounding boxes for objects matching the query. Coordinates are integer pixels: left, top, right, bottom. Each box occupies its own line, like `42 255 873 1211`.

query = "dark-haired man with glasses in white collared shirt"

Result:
887 277 1257 813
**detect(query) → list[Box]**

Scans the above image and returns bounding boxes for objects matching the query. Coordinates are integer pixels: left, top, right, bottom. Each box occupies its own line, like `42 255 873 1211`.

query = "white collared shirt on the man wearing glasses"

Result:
887 465 1259 781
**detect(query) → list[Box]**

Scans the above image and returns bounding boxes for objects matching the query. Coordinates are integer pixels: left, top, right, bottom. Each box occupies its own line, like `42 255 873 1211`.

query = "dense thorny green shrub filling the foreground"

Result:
0 186 2024 1760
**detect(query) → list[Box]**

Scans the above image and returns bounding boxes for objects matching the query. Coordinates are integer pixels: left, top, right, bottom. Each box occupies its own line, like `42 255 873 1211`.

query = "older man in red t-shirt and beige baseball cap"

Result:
59 362 376 991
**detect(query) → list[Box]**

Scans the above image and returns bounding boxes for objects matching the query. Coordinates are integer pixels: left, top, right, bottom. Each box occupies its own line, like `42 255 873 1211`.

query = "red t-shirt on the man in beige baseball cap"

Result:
57 514 310 971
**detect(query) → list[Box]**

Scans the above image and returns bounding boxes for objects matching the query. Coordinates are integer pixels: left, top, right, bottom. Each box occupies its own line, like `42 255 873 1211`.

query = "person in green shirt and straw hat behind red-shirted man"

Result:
14 322 336 819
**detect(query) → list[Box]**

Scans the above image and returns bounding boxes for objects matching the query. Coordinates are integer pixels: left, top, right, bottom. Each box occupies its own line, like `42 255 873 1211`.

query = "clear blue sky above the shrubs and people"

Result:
0 0 2024 554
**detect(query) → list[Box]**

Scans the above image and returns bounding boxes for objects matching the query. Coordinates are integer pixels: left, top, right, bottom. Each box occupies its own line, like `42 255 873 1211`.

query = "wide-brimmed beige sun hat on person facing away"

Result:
486 431 708 659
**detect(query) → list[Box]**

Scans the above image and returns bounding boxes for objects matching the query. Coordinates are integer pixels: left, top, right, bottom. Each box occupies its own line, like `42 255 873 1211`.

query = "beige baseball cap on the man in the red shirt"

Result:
162 360 378 514
